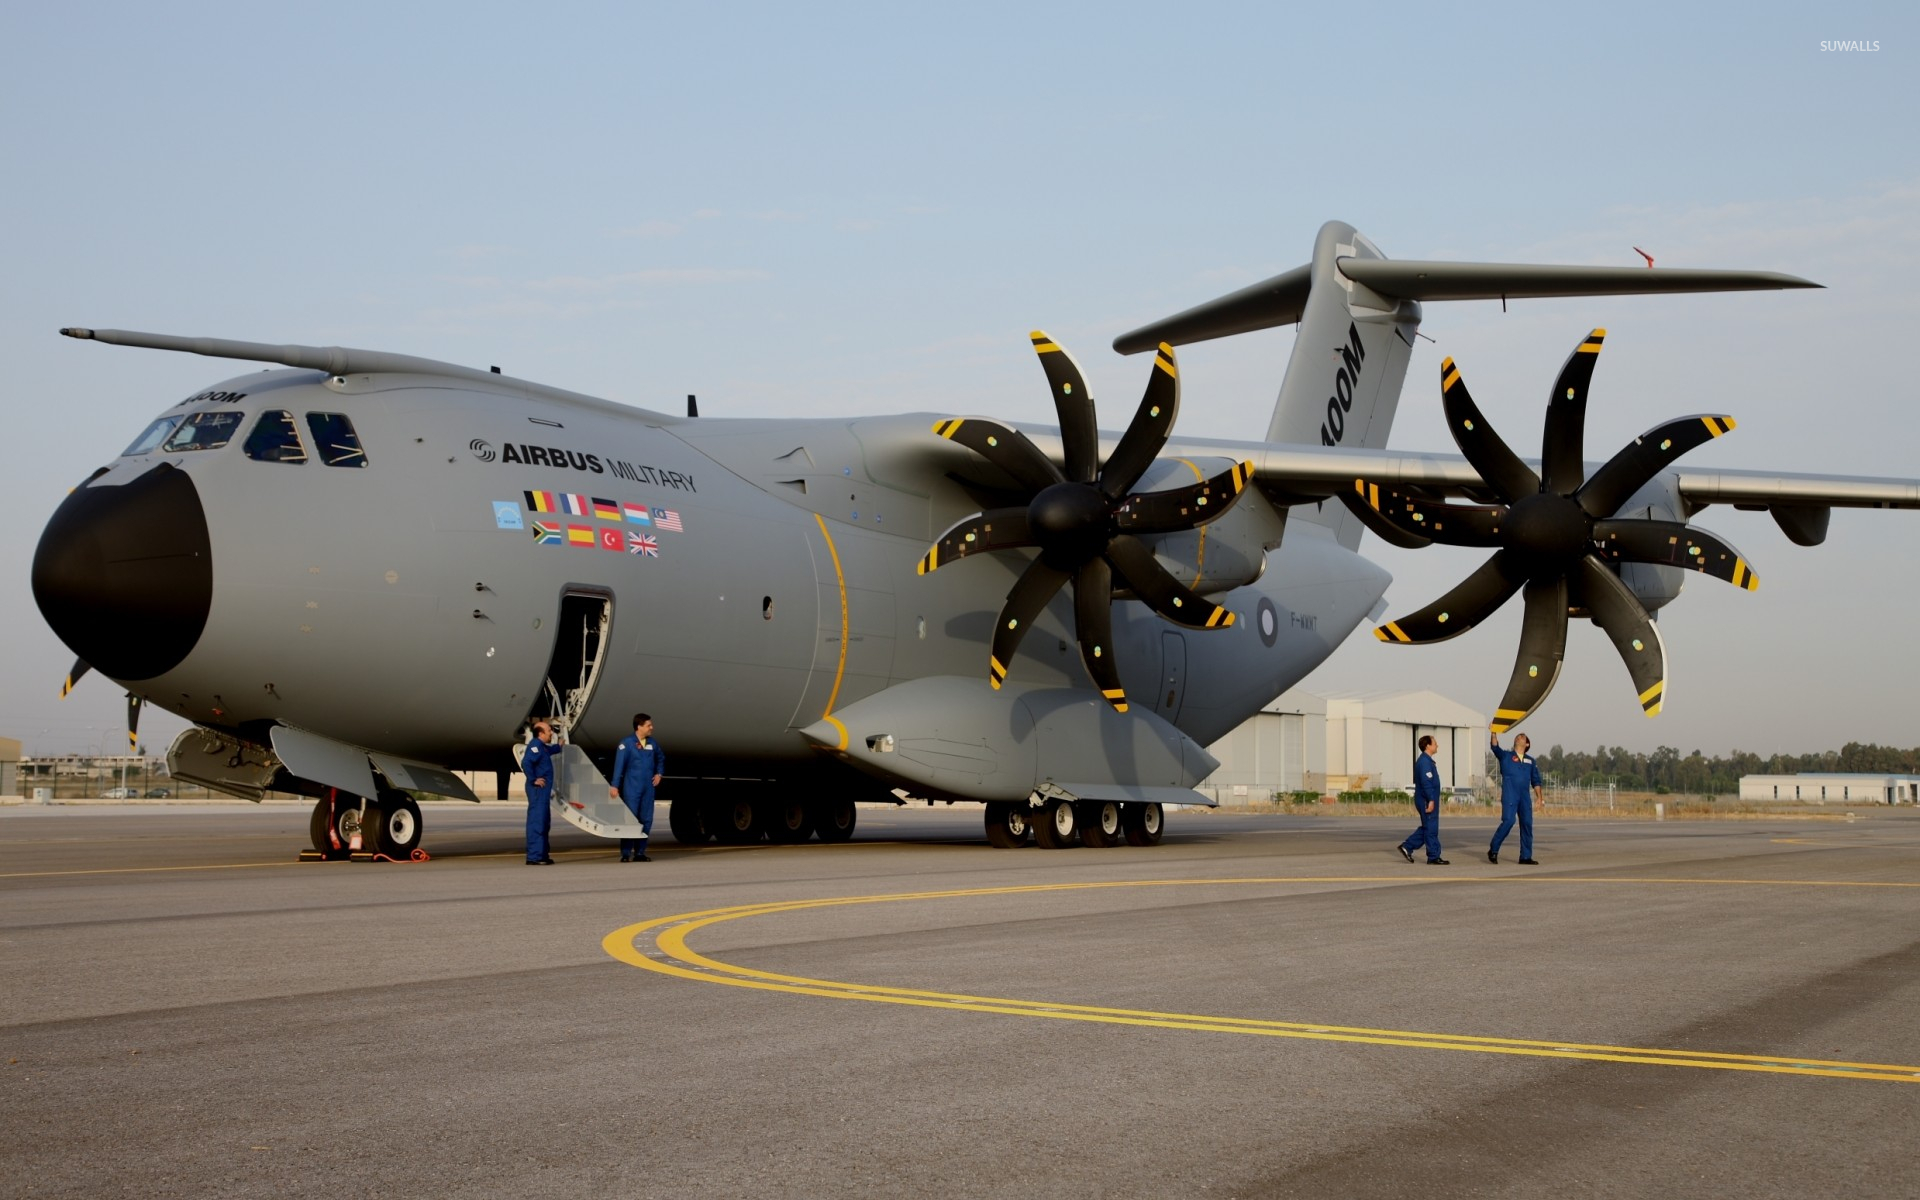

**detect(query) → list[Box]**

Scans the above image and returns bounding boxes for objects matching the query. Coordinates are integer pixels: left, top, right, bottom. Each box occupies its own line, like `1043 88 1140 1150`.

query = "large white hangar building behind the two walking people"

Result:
1198 687 1486 804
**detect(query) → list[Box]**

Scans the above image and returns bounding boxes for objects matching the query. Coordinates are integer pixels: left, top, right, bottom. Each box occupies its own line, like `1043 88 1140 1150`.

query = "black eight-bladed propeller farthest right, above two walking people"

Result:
1354 328 1759 733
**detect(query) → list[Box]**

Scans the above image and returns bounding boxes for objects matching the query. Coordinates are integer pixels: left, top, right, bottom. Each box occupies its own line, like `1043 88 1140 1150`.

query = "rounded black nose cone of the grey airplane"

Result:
33 463 213 680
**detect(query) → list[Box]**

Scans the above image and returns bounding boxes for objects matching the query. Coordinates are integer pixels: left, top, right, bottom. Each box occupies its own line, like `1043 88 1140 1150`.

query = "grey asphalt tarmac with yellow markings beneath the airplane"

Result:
0 804 1920 1198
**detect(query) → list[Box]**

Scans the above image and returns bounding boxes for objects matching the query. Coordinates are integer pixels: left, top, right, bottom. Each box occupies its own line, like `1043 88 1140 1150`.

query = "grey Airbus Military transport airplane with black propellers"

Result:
33 221 1920 858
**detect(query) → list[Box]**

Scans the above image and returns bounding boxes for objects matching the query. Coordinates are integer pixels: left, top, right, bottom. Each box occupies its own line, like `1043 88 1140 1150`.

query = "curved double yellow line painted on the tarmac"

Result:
601 876 1920 1083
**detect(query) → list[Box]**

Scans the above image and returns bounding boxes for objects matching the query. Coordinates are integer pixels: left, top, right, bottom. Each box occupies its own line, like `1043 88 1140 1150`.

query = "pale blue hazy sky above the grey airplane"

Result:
0 0 1920 753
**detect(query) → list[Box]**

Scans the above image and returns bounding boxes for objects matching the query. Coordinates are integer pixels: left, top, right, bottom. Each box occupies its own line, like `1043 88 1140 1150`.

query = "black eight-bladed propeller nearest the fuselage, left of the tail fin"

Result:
920 330 1254 712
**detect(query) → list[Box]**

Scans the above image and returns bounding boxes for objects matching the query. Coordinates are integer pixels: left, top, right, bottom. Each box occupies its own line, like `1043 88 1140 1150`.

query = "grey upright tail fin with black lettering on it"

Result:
1267 221 1421 549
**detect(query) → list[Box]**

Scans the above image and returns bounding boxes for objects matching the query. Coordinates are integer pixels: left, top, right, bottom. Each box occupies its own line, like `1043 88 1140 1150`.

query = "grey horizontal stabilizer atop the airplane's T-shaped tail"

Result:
1114 257 1820 353
